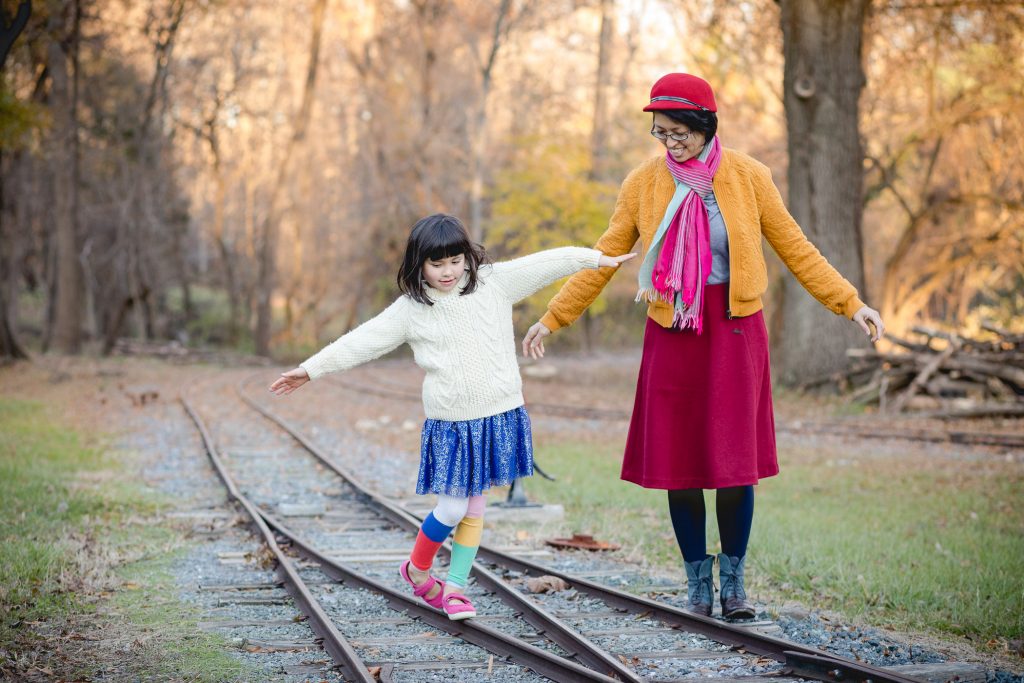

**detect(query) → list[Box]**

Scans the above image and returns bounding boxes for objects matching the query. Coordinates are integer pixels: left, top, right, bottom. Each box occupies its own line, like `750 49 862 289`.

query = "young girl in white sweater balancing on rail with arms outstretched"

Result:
270 214 635 620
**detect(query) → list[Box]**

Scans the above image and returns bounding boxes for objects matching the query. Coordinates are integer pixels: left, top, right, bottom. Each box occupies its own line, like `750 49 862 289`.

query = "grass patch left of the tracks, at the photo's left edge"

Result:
0 397 253 681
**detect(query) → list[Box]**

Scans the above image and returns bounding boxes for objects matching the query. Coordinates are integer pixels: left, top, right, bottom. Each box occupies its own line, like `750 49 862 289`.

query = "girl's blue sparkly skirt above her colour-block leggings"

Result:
416 405 534 498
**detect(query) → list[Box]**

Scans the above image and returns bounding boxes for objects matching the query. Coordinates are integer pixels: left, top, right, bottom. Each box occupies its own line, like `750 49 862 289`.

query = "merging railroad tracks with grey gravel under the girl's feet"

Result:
174 376 929 683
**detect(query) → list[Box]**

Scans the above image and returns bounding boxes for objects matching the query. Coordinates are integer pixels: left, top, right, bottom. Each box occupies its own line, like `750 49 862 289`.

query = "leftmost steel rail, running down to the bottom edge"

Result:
181 396 375 683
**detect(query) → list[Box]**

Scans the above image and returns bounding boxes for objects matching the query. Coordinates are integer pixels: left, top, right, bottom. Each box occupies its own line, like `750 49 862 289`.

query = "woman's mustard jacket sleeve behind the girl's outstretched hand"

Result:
541 171 640 332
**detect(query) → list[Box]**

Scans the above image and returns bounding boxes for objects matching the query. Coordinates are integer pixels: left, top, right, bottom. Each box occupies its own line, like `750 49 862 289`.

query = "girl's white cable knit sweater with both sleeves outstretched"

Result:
300 247 601 421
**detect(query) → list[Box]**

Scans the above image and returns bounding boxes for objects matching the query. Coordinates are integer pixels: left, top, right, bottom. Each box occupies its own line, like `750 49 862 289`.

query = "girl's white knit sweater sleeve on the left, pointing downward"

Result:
299 297 409 380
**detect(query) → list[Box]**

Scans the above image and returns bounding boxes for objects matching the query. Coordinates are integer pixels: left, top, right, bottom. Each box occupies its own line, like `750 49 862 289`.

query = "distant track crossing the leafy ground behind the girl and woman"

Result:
329 370 1024 449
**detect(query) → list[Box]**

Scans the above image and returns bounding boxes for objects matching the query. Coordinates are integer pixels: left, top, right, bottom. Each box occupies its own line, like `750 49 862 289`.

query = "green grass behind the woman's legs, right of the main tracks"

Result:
530 439 1024 647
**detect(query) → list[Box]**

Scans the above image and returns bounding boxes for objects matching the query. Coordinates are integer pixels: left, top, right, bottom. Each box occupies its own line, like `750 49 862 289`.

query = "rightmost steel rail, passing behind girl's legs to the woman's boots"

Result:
236 380 922 683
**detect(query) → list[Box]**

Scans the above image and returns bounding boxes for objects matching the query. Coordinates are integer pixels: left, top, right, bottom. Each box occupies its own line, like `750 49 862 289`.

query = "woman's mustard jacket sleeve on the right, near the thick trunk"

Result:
756 167 864 317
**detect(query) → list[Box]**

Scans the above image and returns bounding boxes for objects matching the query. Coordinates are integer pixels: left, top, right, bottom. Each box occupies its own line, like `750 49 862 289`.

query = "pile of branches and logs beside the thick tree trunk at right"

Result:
834 325 1024 418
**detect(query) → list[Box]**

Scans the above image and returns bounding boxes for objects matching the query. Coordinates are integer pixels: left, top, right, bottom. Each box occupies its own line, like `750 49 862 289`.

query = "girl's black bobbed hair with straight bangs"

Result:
398 213 488 306
